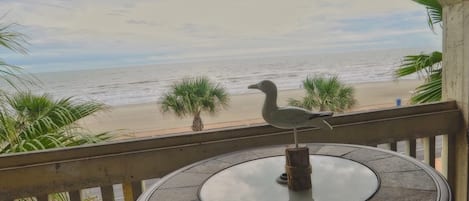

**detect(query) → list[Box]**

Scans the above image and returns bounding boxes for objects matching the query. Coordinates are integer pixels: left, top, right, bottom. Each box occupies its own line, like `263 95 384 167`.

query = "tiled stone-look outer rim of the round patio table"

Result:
138 143 451 201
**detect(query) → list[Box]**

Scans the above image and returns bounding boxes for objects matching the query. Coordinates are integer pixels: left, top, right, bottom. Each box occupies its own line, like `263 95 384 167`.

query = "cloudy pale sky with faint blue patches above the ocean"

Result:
0 0 441 72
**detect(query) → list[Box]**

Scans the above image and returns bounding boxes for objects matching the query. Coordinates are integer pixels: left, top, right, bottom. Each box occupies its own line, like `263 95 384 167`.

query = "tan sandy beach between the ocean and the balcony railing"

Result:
81 80 422 137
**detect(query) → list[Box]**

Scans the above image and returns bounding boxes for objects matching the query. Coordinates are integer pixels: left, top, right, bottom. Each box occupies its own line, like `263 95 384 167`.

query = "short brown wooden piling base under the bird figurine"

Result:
285 147 311 191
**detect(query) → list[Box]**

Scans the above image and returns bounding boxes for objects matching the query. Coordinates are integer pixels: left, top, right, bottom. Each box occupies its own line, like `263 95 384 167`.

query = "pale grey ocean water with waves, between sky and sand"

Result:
27 50 419 106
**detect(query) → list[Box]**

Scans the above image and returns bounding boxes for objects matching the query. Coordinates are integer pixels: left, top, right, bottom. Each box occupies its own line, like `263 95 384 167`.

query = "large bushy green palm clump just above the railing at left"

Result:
0 92 111 154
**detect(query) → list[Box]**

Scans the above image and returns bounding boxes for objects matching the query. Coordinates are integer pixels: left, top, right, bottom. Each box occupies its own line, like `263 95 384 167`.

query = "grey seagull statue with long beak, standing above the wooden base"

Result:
248 80 333 148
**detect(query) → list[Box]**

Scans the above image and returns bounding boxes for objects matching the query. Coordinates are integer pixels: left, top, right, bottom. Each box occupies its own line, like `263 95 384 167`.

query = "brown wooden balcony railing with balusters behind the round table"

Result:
0 102 463 201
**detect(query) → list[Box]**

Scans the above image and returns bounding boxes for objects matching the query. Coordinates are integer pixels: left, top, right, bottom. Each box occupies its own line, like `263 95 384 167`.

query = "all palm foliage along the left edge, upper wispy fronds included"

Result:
0 21 109 201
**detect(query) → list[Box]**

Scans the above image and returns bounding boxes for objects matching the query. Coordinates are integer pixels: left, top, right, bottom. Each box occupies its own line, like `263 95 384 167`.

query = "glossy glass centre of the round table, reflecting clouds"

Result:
199 155 379 201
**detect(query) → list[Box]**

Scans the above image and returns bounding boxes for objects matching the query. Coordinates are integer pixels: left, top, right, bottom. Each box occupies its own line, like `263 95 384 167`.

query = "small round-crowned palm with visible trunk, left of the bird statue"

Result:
161 77 229 131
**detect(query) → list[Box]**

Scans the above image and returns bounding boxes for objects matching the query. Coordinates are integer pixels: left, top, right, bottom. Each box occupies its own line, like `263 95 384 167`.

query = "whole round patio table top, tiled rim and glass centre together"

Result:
138 143 451 201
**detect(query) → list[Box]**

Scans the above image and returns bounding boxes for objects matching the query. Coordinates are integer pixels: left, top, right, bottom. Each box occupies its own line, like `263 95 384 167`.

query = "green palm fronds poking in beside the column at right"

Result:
395 0 443 104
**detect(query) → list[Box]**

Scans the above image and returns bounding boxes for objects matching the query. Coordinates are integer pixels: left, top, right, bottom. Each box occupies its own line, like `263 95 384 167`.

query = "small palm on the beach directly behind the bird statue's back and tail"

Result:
288 76 356 112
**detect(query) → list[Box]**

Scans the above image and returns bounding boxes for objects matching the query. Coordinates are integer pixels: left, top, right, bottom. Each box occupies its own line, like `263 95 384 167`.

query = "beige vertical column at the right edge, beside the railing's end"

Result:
440 0 469 201
